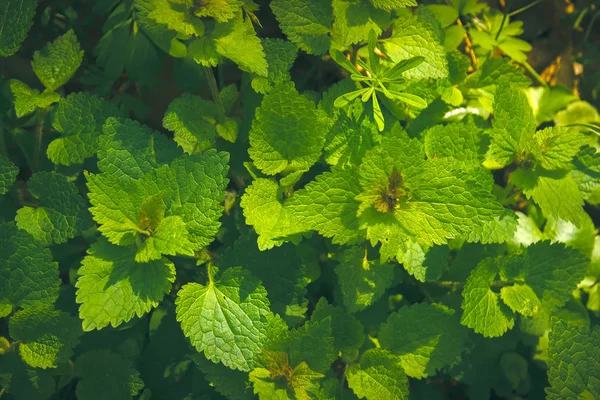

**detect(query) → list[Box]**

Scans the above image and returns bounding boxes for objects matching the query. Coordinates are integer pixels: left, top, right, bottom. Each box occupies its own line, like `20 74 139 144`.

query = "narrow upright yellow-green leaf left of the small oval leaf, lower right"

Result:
460 258 515 337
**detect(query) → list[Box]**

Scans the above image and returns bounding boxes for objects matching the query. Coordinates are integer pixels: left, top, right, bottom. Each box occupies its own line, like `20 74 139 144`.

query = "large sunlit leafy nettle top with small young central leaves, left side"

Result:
86 118 228 262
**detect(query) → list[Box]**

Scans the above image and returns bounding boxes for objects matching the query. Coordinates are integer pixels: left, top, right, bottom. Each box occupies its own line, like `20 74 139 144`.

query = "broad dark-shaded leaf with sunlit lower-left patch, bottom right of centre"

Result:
378 303 467 379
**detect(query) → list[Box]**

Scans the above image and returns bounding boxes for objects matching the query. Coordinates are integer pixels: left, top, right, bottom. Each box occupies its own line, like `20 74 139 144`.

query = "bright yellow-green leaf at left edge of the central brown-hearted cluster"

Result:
240 178 307 250
